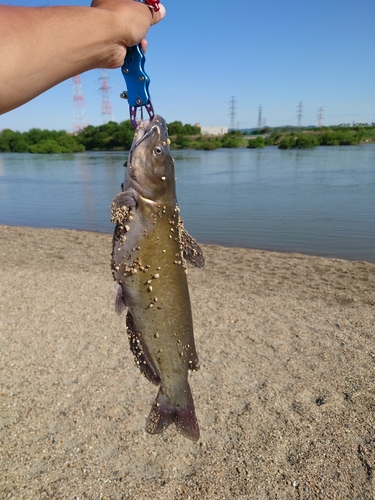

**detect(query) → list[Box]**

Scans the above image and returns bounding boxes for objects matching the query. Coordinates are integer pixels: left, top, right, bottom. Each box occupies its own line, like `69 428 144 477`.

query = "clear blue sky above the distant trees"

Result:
0 0 375 131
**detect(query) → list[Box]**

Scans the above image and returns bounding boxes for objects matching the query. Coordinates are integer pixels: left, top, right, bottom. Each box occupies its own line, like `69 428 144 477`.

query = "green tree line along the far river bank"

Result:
0 120 375 153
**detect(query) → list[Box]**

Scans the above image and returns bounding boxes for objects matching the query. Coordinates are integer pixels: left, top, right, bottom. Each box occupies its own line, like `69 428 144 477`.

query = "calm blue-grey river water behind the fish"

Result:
0 145 375 262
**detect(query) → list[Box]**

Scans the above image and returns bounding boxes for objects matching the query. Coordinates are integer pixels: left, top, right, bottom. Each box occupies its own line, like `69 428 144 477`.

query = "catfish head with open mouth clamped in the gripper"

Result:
125 115 176 202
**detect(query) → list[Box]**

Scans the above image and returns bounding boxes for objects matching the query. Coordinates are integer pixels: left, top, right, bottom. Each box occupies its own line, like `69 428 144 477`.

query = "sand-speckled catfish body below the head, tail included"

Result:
113 201 199 440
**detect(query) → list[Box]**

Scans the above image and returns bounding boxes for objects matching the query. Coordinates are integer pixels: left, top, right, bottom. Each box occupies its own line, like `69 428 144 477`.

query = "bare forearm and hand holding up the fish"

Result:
0 0 165 114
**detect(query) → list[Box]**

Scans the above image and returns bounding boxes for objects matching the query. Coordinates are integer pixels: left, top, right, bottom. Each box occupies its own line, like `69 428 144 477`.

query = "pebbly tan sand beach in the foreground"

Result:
0 226 375 500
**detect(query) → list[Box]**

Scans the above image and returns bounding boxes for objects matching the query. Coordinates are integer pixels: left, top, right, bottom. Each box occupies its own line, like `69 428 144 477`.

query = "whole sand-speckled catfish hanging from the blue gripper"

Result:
110 115 204 441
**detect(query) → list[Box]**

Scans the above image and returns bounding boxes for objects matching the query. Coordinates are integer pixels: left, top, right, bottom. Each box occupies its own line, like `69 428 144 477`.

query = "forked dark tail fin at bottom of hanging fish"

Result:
146 384 199 441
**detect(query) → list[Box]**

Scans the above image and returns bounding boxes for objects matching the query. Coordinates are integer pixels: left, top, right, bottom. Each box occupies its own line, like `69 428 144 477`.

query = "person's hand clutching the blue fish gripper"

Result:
91 0 166 68
